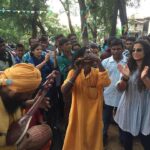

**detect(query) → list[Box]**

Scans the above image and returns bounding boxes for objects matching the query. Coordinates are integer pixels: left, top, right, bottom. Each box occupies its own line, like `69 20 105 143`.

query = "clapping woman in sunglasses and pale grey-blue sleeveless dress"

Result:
115 40 150 150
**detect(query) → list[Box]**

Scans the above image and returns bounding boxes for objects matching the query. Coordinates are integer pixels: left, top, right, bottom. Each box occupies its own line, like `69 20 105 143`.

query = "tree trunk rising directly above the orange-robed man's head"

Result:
78 0 89 46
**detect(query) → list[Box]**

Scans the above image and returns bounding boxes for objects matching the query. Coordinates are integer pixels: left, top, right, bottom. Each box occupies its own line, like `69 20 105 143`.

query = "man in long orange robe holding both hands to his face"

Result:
61 49 110 150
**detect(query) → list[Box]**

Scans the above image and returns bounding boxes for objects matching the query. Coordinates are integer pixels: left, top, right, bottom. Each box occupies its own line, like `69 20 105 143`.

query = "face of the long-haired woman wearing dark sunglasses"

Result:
132 43 144 61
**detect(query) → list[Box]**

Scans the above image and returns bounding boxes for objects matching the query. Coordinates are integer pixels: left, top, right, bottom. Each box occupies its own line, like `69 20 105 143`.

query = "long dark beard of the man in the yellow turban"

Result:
0 91 23 114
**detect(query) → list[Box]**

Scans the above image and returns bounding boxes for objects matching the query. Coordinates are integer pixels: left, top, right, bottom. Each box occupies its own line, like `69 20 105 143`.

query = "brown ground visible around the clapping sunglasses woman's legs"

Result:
105 125 143 150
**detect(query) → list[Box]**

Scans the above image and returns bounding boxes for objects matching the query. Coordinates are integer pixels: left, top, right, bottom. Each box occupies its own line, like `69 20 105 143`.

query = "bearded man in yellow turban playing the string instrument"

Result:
0 63 54 150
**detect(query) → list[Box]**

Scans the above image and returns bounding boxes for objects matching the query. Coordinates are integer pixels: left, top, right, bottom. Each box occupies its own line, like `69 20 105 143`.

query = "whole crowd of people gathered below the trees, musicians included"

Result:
0 34 150 150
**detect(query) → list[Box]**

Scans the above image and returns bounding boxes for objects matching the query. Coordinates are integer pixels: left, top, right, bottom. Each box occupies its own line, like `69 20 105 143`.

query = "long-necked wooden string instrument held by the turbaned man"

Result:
6 71 58 145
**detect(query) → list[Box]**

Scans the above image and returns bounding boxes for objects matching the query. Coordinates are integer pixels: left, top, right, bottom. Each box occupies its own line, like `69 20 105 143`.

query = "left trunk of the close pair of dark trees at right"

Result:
110 0 119 36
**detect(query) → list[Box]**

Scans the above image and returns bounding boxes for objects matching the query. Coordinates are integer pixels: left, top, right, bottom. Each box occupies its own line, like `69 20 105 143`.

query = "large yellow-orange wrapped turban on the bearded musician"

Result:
0 63 41 93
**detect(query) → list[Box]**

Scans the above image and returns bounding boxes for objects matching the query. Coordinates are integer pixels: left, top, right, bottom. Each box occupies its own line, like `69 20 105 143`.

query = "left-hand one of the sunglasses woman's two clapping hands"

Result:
118 64 130 79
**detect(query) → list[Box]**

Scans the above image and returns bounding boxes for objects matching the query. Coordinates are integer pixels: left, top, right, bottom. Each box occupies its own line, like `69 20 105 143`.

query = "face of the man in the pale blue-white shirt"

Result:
111 45 123 59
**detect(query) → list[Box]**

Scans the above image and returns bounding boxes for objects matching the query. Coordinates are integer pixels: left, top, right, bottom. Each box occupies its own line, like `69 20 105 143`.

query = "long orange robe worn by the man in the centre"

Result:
62 68 110 150
